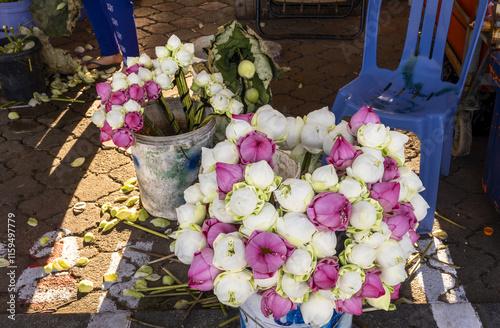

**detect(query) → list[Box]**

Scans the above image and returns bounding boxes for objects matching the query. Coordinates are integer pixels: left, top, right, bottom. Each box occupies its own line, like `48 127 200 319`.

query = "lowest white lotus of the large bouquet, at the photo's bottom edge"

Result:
300 293 335 327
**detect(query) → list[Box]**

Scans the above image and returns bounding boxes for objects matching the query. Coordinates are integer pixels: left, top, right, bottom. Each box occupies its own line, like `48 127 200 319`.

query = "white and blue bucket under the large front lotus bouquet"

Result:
239 294 352 328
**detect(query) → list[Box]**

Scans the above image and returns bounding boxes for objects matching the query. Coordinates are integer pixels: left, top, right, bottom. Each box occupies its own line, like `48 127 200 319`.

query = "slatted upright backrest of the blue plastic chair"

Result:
361 0 488 93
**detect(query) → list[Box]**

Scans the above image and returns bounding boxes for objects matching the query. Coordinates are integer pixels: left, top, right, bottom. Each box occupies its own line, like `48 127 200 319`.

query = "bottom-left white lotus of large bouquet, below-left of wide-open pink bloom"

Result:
214 271 255 307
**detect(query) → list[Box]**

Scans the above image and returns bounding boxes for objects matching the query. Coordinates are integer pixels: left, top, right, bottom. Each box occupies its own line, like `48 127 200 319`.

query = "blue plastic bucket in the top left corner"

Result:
0 0 35 33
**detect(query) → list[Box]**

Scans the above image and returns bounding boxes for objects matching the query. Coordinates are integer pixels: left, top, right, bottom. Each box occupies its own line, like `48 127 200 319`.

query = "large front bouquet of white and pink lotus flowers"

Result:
170 106 428 326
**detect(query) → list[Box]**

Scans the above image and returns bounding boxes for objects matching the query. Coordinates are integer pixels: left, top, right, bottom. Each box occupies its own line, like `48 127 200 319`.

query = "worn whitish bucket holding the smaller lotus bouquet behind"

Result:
131 107 215 220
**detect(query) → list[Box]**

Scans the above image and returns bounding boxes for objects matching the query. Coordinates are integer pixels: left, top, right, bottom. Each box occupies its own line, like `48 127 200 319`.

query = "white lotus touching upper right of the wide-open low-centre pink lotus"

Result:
276 212 316 247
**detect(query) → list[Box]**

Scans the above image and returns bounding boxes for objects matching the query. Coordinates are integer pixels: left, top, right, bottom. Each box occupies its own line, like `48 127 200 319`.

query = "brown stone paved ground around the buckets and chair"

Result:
0 0 500 327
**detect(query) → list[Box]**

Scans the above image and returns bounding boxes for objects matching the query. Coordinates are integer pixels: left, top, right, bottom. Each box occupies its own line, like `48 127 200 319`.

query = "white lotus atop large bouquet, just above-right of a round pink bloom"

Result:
252 105 288 142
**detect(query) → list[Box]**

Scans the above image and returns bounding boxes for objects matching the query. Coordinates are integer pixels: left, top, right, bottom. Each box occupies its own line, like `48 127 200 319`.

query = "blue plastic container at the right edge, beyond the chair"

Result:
483 52 500 213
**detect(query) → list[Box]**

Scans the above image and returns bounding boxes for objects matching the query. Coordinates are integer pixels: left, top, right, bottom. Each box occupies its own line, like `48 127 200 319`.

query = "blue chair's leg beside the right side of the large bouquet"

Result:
417 124 444 234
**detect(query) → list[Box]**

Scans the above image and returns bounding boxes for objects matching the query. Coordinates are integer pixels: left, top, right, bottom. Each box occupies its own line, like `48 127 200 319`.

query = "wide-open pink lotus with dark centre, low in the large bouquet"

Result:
245 230 295 279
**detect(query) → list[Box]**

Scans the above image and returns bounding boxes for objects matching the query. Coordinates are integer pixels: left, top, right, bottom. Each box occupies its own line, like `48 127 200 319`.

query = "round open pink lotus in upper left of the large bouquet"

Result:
236 131 276 167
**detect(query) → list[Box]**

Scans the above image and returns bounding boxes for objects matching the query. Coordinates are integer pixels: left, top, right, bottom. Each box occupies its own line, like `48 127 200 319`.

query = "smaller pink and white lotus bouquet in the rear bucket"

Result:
92 35 243 149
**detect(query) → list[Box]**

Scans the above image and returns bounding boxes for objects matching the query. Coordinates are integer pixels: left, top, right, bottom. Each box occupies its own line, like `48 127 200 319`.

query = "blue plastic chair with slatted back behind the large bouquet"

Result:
332 0 488 233
